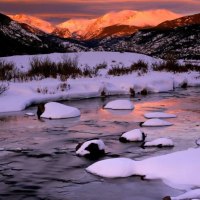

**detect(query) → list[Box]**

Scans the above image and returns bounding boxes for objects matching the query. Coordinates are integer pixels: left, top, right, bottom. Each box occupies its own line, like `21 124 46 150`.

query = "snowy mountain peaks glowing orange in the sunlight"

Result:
10 10 180 40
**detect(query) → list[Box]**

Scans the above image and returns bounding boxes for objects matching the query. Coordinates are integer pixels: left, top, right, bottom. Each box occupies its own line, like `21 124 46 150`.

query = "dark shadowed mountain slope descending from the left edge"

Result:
0 14 86 56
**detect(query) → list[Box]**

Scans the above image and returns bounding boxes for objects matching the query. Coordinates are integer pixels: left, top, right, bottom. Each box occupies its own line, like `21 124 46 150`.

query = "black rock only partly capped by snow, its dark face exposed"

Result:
76 139 105 159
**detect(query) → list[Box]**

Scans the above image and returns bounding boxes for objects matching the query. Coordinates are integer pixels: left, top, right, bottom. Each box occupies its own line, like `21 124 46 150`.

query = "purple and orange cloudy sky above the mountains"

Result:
0 0 200 23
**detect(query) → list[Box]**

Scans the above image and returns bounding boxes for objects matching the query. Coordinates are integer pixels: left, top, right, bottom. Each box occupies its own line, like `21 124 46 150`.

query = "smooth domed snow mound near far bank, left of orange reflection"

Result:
104 100 134 110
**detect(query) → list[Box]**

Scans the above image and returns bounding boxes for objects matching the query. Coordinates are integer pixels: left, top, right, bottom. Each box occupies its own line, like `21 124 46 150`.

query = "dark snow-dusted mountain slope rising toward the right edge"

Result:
96 14 200 59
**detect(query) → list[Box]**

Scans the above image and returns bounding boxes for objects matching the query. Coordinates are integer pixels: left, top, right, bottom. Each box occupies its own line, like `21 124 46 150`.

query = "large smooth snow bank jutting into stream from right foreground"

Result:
86 148 200 190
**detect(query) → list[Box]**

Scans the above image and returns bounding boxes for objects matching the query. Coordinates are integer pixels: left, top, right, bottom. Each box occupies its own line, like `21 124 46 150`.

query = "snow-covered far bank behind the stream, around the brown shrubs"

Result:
0 52 200 112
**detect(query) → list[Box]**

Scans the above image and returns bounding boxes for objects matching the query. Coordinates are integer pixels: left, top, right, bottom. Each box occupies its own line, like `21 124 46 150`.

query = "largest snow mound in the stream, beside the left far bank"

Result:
41 102 80 119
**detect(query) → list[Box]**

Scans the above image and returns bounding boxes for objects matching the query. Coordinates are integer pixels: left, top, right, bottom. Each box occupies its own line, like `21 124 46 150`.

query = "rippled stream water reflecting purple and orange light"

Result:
0 88 200 200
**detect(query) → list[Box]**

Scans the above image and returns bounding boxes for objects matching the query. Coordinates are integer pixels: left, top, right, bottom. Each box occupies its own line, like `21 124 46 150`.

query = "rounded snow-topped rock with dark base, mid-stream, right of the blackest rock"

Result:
119 129 146 142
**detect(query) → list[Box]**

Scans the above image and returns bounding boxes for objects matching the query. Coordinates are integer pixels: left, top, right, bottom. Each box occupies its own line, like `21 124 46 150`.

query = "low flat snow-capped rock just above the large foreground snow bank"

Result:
141 138 174 148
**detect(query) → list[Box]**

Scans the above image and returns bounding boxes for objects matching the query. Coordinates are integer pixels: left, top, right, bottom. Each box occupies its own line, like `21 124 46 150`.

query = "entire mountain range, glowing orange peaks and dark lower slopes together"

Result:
0 10 200 59
